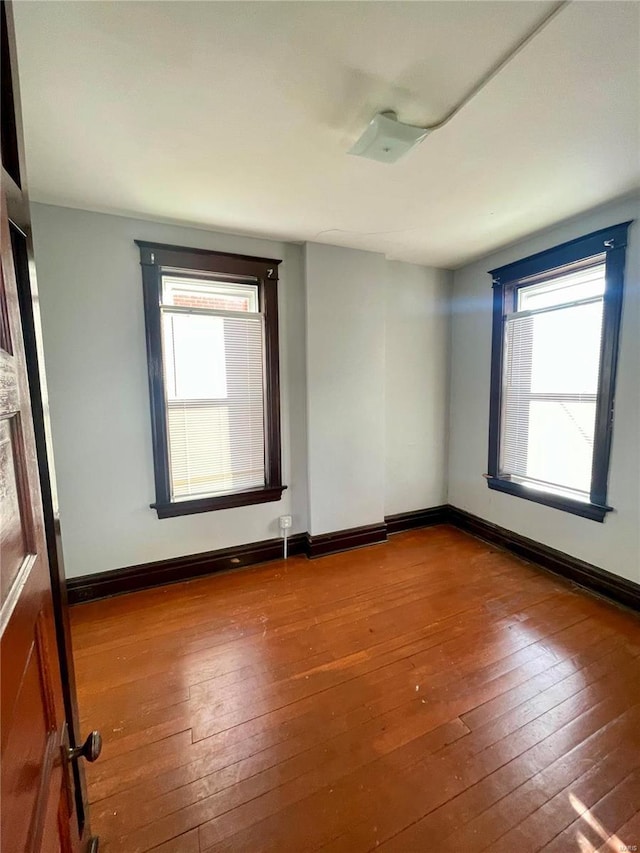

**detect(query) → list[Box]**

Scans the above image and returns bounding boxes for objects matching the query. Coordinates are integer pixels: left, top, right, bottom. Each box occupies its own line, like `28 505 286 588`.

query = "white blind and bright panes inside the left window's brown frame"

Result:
161 275 265 500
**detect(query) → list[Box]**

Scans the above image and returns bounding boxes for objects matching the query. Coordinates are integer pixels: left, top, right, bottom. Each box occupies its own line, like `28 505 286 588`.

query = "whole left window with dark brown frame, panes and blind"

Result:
136 241 285 518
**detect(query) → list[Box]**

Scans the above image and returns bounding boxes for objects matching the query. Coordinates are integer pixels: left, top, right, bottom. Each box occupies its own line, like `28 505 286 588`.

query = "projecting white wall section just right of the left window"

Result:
305 243 386 535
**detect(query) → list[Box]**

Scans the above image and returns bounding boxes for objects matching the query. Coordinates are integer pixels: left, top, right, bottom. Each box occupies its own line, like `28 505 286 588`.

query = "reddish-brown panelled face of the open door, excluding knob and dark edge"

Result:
0 176 80 853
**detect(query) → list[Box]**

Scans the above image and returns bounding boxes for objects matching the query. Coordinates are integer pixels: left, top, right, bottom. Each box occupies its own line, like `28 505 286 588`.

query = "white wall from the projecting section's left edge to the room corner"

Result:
305 243 452 535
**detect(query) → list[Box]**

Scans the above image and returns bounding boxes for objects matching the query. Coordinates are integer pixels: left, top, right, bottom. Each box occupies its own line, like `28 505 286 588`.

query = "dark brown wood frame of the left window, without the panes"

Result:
135 240 286 518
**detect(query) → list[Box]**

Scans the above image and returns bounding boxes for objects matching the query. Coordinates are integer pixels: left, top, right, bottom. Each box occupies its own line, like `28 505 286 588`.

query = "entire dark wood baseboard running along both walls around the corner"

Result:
67 505 640 610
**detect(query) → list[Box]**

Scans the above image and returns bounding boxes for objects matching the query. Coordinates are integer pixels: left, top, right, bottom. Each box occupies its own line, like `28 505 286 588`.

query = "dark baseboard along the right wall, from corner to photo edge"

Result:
448 506 640 610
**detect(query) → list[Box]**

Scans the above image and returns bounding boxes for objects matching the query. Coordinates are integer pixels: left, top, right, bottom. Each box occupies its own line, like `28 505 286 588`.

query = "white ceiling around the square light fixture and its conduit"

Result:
15 0 640 267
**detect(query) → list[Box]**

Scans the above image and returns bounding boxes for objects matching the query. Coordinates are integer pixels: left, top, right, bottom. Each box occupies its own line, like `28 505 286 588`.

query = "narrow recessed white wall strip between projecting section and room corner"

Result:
384 261 453 515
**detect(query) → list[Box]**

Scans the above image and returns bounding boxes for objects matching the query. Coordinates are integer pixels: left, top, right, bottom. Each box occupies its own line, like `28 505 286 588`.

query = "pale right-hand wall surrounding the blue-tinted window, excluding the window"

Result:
448 199 640 582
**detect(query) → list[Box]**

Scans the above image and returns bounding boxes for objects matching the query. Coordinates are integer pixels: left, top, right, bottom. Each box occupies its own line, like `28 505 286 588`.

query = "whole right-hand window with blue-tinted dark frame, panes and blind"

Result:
487 222 630 521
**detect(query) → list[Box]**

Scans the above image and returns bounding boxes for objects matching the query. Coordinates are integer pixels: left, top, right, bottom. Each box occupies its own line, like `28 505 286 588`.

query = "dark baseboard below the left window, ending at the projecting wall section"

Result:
67 533 306 604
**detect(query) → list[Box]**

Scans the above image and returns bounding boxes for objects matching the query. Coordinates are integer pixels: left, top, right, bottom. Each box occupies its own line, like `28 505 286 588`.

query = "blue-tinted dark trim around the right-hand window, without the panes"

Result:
486 220 633 522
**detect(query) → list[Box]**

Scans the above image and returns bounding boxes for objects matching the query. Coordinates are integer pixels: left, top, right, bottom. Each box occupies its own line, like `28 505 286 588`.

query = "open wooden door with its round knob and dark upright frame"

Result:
0 0 100 853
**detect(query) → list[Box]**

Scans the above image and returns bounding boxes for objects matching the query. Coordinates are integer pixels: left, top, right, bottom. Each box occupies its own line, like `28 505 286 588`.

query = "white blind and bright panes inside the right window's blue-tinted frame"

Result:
499 258 605 501
